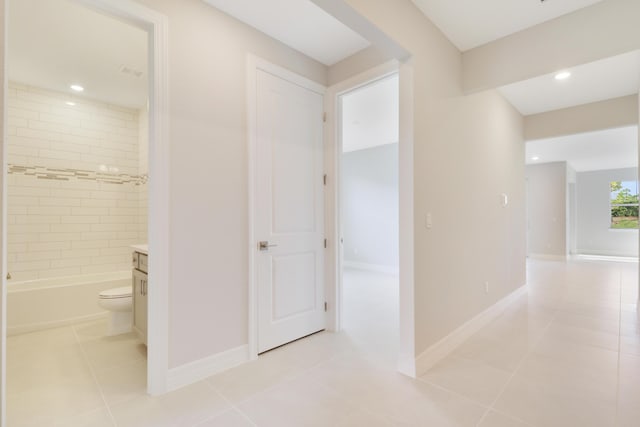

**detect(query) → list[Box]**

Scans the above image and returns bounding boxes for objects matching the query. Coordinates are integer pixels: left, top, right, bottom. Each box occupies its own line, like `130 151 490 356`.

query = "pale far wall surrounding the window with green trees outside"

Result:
577 168 638 256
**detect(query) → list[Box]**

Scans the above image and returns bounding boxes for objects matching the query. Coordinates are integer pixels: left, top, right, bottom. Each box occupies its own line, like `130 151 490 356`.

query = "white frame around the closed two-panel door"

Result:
247 54 328 360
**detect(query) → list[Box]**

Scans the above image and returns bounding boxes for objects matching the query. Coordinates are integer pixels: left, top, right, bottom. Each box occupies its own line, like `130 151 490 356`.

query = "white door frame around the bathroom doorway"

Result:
0 0 170 408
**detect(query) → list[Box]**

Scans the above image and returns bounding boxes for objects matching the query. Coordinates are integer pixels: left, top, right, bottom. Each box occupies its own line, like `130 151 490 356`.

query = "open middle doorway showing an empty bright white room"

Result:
338 72 399 364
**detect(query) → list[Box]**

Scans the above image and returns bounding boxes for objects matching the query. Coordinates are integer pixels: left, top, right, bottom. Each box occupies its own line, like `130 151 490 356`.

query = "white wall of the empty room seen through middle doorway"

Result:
341 143 399 272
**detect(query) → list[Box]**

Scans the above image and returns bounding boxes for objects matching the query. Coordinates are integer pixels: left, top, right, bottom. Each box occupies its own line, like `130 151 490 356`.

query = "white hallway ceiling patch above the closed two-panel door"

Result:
204 0 370 66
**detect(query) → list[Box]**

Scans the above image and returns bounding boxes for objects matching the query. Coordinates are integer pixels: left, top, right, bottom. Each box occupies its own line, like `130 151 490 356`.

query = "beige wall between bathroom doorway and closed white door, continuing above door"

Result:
132 0 327 368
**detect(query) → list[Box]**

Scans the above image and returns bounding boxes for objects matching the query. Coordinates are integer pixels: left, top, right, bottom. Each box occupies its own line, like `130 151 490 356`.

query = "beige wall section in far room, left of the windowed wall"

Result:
526 162 568 258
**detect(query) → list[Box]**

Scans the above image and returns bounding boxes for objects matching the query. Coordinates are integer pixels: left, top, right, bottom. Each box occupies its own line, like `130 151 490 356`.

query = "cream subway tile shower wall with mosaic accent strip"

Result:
7 82 148 282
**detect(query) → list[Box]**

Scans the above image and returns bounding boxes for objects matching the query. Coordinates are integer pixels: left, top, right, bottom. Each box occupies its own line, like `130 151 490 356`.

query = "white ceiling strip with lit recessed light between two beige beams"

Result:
499 51 640 116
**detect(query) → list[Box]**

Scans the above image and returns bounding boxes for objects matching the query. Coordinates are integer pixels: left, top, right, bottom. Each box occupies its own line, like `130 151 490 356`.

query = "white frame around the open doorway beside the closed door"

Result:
325 60 416 377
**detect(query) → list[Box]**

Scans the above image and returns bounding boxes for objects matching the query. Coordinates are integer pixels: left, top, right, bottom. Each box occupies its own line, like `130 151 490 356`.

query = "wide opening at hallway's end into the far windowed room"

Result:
525 125 639 261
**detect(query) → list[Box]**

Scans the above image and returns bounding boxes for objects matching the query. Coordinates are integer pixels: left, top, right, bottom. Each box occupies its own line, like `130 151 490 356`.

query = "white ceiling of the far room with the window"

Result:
526 126 638 172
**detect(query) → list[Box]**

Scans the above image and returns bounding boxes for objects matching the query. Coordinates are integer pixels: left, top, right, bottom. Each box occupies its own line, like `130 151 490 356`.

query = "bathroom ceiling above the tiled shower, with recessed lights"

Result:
7 0 148 108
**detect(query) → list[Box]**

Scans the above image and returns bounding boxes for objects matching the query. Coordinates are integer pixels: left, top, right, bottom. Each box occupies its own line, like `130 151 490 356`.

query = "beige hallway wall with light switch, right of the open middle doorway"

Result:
347 0 525 362
